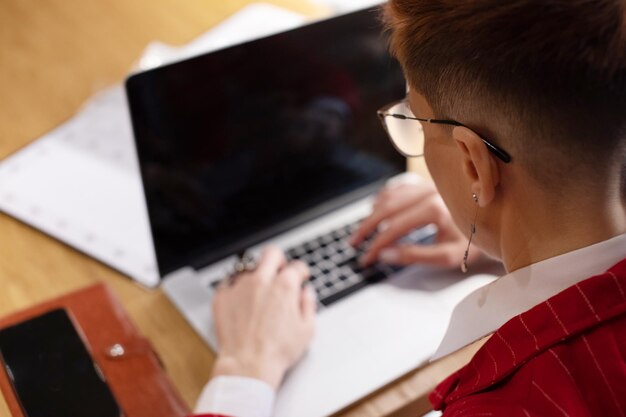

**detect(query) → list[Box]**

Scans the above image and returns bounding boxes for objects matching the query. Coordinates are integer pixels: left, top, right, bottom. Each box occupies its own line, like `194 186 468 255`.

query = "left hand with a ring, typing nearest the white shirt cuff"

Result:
213 247 316 389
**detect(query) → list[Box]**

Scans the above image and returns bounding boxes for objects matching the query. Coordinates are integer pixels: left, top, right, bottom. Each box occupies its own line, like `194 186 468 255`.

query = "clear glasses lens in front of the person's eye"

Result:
384 102 424 156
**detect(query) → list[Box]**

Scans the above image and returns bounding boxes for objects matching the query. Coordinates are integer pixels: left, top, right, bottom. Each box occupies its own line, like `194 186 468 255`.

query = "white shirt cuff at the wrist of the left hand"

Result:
195 376 276 417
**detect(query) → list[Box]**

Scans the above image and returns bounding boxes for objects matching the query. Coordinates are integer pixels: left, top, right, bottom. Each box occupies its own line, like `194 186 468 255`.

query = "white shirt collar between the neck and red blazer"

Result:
432 234 626 360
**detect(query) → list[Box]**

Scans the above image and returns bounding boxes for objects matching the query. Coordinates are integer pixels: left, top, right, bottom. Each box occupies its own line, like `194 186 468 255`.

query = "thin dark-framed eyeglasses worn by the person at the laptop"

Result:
377 99 511 163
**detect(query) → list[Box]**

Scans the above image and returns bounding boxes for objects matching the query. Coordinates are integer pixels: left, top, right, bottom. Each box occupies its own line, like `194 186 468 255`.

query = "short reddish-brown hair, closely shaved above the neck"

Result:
383 0 626 187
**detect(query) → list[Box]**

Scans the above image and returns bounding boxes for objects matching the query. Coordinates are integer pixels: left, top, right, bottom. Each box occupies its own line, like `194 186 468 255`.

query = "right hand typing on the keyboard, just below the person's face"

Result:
351 177 480 267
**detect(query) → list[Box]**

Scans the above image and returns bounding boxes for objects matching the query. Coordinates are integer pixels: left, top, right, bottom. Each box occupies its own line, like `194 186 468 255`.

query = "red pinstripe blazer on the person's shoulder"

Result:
197 255 626 417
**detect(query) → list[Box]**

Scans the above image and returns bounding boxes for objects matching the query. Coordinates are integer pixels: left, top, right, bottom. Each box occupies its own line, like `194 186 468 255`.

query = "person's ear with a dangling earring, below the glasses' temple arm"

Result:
452 126 500 206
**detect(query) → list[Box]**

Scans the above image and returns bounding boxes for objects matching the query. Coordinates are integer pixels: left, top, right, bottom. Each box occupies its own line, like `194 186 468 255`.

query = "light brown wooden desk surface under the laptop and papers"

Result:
0 0 480 417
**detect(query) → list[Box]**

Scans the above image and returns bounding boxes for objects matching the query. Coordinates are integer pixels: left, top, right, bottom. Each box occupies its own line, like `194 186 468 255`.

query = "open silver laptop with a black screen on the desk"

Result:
126 8 498 417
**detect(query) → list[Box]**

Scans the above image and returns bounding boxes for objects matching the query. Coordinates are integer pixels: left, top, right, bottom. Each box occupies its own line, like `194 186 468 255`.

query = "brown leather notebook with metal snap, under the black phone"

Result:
0 284 189 417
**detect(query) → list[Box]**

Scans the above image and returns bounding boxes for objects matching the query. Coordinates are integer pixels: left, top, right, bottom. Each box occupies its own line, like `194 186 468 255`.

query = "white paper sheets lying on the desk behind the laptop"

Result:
0 3 305 287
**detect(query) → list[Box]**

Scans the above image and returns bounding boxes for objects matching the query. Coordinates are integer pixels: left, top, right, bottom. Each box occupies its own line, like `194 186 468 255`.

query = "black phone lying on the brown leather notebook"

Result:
0 309 122 417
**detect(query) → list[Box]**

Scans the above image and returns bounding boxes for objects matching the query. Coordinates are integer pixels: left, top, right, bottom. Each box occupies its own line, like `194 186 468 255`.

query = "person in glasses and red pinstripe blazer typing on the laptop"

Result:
193 0 626 417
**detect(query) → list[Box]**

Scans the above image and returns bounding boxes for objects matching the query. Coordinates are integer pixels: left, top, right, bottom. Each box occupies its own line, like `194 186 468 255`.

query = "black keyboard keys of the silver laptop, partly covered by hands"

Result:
286 221 433 306
